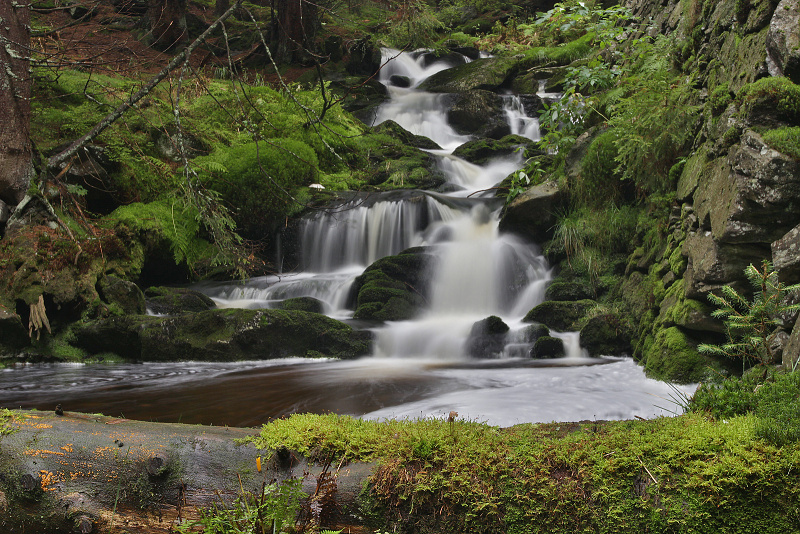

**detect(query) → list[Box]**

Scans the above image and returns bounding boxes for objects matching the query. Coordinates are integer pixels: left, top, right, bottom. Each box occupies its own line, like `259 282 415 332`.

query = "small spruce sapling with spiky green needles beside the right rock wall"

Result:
698 260 800 367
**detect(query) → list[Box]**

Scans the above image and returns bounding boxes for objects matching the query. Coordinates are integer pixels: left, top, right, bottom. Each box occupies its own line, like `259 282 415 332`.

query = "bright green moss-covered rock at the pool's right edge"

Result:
643 326 719 384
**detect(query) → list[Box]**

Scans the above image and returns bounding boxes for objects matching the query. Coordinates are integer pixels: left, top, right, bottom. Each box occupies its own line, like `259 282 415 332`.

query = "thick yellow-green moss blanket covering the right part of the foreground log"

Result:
254 414 800 534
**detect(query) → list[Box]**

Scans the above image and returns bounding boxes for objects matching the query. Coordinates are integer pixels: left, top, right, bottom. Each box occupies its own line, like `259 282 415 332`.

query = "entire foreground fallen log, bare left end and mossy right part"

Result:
0 412 800 534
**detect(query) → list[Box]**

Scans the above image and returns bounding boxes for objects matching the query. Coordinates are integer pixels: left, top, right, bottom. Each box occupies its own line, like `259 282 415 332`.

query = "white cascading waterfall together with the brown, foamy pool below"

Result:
0 50 692 426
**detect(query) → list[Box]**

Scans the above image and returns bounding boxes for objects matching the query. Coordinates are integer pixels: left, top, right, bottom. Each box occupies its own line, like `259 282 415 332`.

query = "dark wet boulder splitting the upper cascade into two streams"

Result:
447 90 511 139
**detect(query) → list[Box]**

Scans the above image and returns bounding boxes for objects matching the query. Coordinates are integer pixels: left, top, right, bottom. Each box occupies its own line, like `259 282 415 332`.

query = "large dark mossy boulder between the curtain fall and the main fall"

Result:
352 247 433 321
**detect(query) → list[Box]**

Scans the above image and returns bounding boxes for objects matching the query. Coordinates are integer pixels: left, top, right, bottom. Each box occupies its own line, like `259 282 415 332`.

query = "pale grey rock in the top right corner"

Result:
767 0 800 84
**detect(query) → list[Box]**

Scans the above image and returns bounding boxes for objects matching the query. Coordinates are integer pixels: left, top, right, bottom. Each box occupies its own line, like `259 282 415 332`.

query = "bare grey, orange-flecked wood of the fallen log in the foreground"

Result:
0 411 372 534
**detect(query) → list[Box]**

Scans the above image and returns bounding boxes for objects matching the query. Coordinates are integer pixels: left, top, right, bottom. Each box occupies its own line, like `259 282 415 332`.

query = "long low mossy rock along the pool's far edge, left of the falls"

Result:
75 309 371 361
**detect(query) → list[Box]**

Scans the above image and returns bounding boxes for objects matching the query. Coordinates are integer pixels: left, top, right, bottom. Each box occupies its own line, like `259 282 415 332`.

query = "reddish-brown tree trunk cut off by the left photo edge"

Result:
0 0 35 205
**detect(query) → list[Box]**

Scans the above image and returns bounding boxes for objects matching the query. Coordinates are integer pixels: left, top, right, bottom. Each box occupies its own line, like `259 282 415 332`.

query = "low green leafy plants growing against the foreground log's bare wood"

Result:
178 478 307 534
